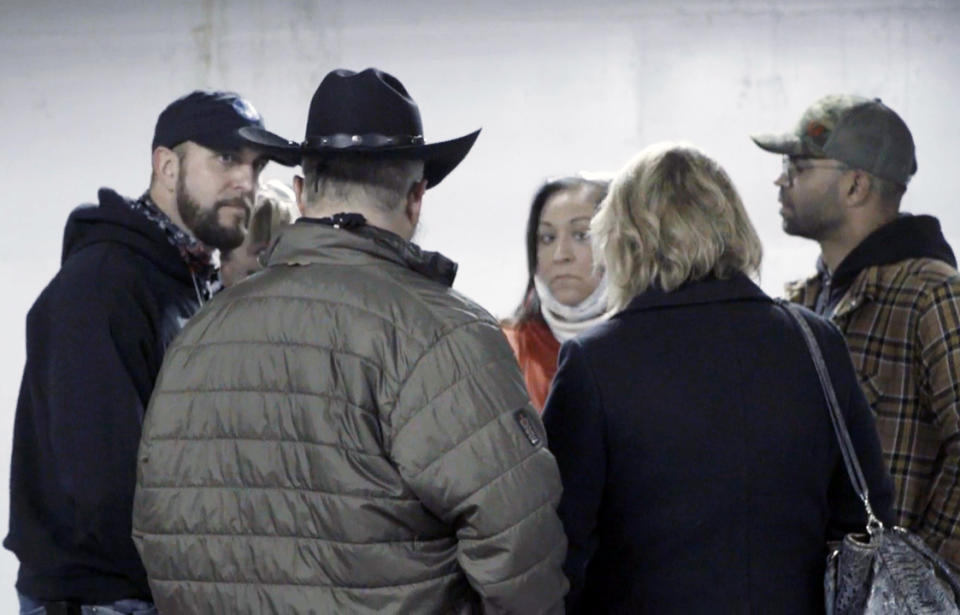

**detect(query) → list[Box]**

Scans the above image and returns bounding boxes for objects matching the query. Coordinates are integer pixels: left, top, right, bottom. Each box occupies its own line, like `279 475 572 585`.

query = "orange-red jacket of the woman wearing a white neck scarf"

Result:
503 318 560 412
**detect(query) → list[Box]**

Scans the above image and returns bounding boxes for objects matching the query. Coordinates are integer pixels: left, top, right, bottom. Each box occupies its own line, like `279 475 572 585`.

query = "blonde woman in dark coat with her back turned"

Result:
544 144 892 613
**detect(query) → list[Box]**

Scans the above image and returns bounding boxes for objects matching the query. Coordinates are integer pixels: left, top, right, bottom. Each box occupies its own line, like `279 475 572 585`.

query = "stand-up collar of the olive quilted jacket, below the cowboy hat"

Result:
266 218 457 286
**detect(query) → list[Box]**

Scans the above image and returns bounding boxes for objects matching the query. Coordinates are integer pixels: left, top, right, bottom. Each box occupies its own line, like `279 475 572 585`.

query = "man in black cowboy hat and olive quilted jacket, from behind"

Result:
134 69 567 613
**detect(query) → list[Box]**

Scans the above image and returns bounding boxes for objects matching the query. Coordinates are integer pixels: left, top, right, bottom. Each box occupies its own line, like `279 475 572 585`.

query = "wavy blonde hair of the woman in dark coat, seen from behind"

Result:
590 143 763 309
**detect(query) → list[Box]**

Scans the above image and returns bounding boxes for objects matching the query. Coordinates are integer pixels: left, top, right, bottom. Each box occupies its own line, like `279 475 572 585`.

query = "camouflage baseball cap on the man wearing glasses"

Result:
750 94 917 186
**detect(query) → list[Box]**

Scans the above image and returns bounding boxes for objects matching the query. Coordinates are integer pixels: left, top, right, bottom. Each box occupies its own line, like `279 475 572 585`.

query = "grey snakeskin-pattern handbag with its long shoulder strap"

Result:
777 300 960 615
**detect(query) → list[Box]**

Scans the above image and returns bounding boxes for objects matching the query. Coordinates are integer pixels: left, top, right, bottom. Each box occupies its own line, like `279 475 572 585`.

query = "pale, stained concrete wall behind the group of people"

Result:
0 0 960 610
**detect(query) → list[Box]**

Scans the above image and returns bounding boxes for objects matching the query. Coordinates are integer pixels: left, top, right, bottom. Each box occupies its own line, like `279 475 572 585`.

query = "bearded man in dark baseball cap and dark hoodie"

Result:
4 91 266 614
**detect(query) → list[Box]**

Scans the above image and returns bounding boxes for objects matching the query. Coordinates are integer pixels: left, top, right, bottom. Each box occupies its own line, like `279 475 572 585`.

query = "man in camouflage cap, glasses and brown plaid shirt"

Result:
752 95 960 569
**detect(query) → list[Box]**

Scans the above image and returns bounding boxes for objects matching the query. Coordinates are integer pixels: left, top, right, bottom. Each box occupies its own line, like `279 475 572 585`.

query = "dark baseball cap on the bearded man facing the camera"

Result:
151 90 263 151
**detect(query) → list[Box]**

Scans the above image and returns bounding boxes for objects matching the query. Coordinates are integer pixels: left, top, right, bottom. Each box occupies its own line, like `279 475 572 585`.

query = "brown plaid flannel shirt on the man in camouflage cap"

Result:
787 258 960 569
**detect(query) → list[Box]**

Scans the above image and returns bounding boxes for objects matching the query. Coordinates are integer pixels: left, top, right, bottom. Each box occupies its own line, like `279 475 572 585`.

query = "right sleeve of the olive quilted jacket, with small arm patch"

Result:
388 320 567 613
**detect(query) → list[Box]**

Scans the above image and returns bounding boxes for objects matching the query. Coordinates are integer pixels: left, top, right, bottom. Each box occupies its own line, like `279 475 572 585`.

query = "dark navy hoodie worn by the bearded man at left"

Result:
4 189 200 604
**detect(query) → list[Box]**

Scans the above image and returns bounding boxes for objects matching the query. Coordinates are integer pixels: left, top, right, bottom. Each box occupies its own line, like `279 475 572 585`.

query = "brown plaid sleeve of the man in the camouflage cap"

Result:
915 277 960 570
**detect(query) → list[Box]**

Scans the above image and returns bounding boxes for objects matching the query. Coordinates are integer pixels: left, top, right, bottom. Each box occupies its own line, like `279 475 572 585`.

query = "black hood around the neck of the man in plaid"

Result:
832 213 957 285
